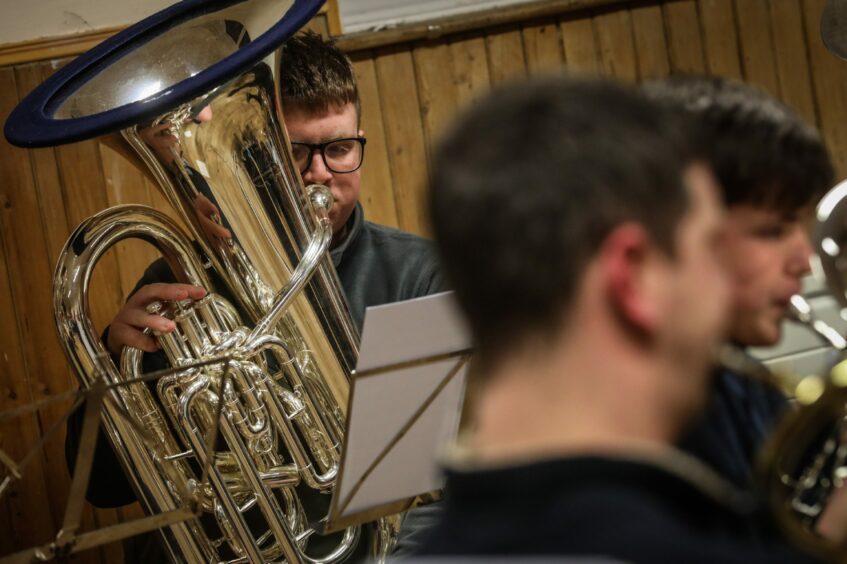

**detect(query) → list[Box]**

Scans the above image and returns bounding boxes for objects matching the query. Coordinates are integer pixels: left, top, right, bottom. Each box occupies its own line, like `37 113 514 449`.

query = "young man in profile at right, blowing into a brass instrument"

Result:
645 77 833 487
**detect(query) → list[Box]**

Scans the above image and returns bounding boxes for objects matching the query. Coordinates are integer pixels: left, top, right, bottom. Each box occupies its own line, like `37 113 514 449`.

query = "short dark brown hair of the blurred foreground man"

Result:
429 77 702 362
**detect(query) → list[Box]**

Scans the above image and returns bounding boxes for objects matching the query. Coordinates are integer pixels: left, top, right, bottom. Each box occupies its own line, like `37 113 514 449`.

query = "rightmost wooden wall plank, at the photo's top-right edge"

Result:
802 0 847 178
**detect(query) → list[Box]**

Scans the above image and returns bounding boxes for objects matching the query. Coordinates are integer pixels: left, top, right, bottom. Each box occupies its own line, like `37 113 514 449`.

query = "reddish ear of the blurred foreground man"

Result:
600 223 662 335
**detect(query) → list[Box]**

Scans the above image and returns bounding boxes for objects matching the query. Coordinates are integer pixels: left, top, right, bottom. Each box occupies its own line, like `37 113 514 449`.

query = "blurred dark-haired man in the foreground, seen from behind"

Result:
422 79 820 563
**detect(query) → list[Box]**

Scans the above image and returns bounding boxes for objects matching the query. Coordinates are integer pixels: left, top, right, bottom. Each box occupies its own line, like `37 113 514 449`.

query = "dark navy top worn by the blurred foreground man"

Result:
417 449 814 564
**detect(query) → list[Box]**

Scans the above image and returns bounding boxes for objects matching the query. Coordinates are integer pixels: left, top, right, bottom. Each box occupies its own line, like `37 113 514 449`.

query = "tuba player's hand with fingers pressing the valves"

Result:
106 284 206 355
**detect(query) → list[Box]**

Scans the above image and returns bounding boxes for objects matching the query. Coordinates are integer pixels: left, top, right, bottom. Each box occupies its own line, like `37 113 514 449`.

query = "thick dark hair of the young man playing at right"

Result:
644 76 834 213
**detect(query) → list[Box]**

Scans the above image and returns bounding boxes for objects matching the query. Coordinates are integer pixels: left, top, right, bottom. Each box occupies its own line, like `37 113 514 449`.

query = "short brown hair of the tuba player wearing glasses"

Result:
280 31 361 117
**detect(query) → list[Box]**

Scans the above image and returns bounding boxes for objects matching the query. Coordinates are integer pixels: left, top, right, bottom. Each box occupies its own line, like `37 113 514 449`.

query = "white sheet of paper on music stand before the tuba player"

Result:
335 292 470 515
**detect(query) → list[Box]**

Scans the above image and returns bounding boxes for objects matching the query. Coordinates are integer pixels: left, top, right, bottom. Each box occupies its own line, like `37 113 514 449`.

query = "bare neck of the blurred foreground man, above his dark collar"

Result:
471 306 692 461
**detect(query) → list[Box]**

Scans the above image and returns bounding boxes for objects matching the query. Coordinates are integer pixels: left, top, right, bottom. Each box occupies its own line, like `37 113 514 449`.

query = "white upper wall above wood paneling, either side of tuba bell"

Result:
0 0 527 45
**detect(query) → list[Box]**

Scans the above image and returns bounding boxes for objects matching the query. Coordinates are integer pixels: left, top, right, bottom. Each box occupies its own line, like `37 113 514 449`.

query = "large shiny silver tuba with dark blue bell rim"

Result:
6 0 397 563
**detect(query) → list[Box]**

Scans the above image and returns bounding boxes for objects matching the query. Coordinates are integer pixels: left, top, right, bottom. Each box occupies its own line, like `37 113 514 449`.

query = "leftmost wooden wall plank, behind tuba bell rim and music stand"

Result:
0 64 56 555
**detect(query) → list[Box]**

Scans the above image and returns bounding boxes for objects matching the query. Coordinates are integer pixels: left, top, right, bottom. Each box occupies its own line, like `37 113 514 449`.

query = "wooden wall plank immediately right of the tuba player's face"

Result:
352 52 399 227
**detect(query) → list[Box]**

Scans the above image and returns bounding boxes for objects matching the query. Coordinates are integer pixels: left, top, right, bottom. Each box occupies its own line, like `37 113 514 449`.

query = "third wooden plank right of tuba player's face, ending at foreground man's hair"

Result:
412 41 457 162
